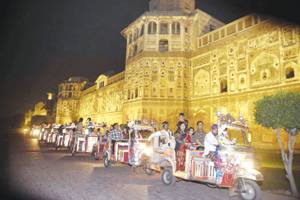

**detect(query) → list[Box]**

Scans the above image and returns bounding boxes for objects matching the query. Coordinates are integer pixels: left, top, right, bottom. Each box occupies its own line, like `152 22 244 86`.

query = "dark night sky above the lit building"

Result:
0 0 298 117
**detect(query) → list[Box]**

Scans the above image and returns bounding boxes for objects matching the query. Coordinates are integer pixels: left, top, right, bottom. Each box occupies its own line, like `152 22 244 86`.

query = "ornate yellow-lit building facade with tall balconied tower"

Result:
57 0 300 148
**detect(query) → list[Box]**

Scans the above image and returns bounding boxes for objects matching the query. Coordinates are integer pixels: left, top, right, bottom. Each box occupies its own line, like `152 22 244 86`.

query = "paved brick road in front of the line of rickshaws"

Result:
1 131 293 200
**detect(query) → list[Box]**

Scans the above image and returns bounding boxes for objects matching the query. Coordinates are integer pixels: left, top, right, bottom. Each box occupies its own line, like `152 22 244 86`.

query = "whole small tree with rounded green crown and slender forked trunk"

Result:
255 91 300 196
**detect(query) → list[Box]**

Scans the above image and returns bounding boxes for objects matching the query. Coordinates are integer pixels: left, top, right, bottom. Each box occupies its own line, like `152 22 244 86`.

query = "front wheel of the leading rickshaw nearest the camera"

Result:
239 179 261 200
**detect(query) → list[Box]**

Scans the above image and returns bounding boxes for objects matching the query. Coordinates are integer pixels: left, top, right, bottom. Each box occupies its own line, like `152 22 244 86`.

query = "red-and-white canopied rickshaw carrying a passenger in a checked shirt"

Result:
103 121 154 167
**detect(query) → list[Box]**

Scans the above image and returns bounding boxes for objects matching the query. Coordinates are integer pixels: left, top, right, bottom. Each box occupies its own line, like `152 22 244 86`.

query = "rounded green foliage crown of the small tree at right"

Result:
255 92 300 134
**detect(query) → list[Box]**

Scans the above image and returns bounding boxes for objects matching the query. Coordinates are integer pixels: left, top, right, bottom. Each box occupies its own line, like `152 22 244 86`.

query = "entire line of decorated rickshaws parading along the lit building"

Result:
27 113 263 200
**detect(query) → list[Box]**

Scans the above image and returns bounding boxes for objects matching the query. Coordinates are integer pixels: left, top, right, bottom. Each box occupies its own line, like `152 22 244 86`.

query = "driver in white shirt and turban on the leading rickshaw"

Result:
204 124 219 156
